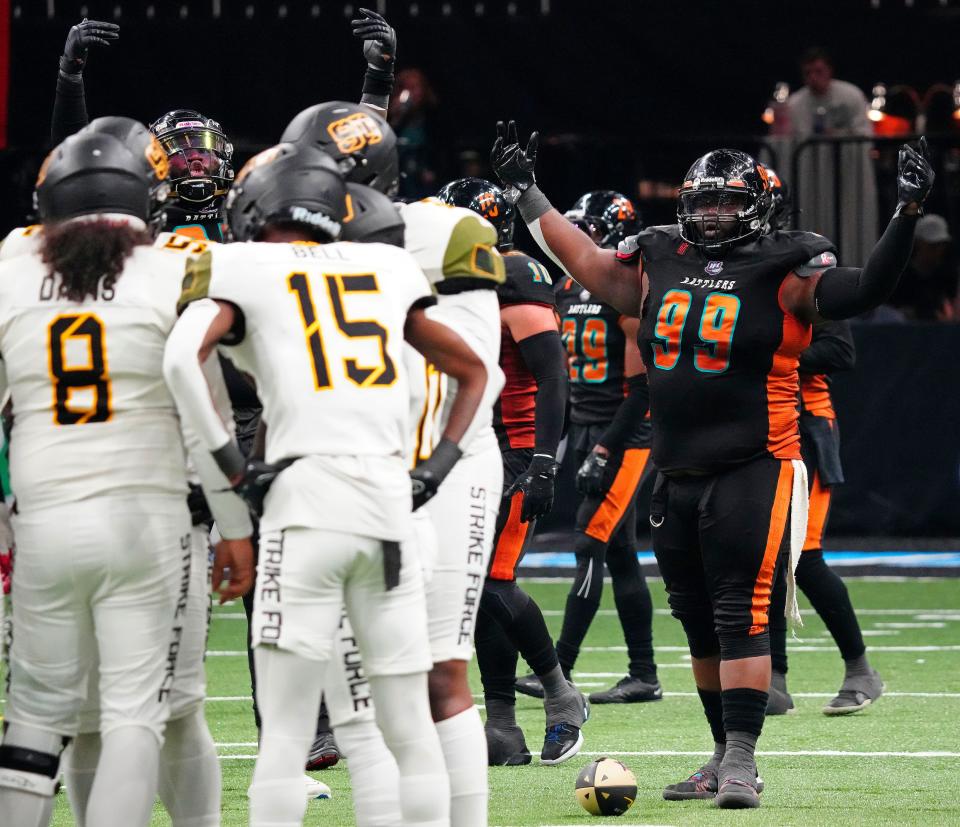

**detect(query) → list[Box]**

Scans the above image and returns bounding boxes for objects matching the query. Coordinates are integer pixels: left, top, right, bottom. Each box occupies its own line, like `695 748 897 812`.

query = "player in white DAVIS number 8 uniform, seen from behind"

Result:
0 119 252 827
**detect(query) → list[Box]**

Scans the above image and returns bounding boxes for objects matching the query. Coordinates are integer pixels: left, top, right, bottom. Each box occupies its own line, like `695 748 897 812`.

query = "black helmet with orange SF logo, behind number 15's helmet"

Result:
280 101 400 197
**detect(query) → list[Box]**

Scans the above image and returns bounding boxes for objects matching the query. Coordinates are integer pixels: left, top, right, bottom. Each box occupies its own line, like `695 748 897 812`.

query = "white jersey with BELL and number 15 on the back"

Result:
180 236 433 540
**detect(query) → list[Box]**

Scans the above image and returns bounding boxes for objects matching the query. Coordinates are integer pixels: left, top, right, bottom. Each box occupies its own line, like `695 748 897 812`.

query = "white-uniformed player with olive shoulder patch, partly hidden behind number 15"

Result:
283 98 503 827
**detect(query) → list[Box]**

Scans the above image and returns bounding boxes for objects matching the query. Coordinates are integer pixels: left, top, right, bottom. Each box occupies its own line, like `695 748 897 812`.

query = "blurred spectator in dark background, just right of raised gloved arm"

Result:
387 69 438 200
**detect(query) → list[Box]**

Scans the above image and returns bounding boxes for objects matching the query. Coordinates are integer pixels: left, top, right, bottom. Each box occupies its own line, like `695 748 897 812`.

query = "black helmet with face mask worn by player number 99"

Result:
677 149 773 255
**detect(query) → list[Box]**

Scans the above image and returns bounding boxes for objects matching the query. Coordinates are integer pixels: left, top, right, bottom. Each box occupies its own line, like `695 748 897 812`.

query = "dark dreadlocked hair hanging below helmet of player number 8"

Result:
40 219 153 302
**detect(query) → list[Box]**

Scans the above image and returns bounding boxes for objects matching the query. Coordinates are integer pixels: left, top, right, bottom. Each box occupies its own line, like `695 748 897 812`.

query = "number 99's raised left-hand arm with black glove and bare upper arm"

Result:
490 121 640 316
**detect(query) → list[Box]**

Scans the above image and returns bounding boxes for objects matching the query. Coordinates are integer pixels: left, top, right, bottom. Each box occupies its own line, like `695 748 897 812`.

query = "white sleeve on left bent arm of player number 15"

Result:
163 299 232 453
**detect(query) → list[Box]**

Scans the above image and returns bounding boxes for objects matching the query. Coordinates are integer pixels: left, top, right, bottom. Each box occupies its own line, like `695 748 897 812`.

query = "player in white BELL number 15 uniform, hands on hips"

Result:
165 144 499 825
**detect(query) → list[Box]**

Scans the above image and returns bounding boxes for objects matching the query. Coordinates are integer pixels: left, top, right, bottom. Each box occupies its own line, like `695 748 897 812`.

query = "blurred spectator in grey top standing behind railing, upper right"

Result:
787 49 877 267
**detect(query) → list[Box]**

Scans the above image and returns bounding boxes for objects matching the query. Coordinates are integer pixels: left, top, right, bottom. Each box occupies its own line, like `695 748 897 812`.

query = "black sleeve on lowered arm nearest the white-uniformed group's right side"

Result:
517 330 570 457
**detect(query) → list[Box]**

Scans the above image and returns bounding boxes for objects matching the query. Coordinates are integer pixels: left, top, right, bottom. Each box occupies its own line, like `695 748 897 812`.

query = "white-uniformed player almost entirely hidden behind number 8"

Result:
0 160 256 827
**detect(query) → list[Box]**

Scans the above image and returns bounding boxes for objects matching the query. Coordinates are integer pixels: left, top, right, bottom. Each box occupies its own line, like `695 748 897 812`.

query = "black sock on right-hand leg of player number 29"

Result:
607 547 657 683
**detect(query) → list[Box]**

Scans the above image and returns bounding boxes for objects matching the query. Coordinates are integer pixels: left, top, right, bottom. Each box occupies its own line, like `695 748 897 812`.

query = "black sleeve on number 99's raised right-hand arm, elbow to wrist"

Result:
814 214 917 319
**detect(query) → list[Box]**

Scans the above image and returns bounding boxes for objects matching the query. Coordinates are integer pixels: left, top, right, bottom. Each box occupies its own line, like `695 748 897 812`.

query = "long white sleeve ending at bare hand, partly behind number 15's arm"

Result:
183 354 253 540
